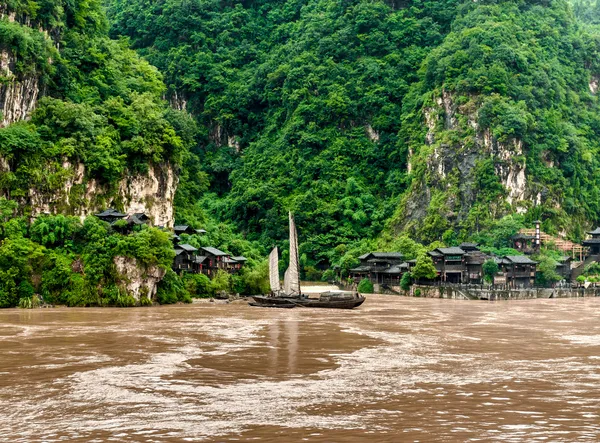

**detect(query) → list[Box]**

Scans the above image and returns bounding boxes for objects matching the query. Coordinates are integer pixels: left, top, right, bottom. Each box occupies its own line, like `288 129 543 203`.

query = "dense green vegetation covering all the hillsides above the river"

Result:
0 0 600 305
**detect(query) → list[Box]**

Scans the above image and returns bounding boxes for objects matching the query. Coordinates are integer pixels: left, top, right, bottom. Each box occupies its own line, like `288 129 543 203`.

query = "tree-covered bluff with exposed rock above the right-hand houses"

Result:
397 1 600 240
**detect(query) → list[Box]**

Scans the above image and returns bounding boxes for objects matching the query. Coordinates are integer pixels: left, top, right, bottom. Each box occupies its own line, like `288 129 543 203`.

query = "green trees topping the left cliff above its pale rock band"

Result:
0 0 188 211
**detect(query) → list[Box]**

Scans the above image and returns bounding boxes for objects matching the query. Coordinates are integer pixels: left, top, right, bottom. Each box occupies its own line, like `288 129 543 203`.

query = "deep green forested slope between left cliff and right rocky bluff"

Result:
109 0 459 265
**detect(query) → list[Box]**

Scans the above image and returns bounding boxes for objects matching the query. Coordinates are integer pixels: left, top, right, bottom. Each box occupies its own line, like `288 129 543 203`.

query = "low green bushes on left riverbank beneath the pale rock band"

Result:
0 198 175 308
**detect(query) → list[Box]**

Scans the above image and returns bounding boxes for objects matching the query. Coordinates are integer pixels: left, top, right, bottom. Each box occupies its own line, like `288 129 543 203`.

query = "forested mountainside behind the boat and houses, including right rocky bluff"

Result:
108 0 600 270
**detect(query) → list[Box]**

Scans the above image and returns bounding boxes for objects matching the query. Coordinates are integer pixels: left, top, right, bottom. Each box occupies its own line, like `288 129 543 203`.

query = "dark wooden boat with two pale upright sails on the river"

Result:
250 212 365 309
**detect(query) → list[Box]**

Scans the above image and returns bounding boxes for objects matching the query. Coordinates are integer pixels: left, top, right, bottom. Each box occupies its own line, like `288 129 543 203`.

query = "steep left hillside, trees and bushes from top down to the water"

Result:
0 0 189 307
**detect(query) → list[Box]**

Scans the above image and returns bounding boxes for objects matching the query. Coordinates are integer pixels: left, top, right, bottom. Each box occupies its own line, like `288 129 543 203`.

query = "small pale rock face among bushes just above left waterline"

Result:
114 256 165 301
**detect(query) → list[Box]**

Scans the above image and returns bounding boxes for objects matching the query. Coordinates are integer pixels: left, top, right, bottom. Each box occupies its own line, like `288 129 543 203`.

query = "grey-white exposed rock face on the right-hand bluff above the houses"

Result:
395 91 539 236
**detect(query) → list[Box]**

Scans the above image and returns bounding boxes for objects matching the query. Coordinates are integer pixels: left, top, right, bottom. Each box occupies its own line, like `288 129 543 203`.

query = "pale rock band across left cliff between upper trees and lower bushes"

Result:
23 160 178 228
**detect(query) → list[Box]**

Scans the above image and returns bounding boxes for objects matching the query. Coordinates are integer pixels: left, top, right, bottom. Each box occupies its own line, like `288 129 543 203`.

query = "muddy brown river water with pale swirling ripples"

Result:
0 296 600 442
